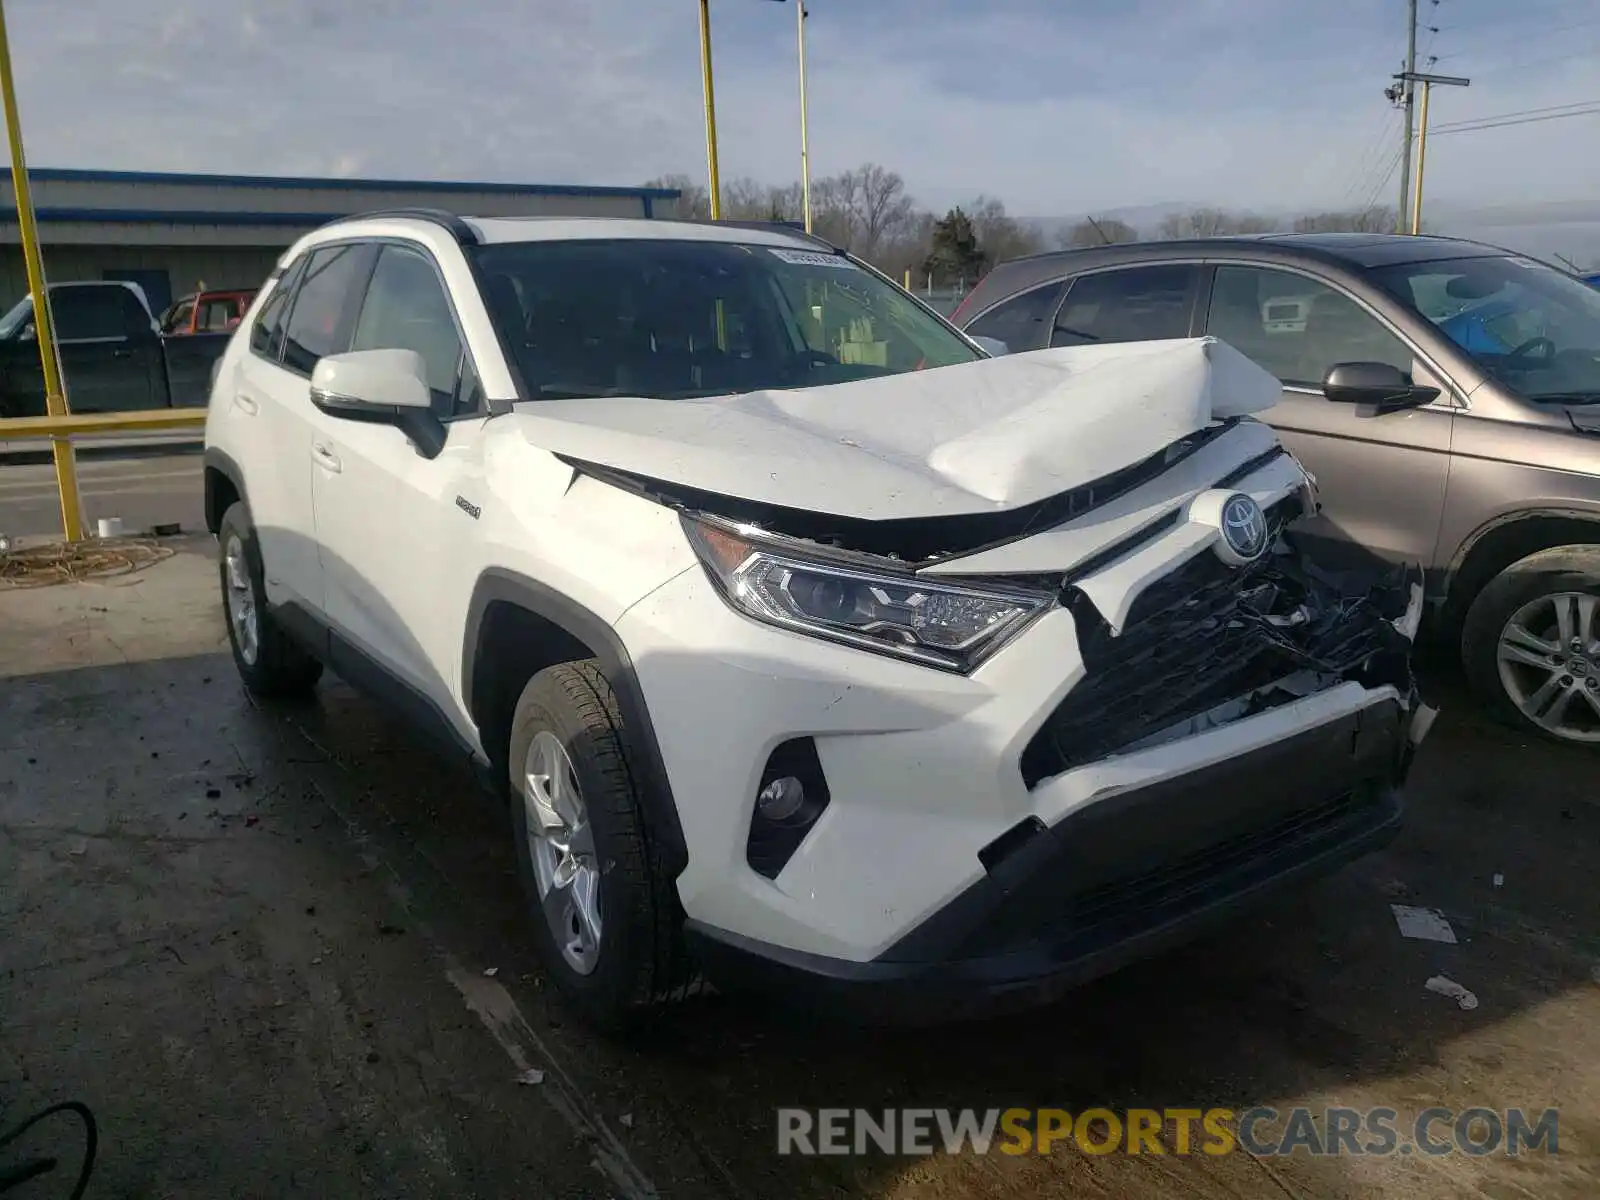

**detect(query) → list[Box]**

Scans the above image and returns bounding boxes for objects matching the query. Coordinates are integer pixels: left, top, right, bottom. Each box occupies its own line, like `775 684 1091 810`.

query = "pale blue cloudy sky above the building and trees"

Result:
5 0 1600 216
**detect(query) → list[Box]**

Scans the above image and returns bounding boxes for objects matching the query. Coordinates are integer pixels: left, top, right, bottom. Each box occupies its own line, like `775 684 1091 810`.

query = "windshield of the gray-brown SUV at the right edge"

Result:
1371 254 1600 403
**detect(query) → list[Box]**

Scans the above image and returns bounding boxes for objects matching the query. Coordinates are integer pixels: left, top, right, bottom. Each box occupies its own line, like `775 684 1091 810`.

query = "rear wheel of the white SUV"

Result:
216 501 322 699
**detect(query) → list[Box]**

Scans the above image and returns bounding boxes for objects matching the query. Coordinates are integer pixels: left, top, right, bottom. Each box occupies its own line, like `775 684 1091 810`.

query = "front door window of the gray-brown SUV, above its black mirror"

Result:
1206 267 1411 387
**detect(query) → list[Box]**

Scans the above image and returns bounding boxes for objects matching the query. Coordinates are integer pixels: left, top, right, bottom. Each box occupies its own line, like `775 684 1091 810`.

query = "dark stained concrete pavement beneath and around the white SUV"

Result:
0 539 1600 1200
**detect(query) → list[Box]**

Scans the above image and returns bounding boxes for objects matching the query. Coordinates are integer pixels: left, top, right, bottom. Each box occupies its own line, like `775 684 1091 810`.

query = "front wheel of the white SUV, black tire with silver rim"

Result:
507 659 691 1032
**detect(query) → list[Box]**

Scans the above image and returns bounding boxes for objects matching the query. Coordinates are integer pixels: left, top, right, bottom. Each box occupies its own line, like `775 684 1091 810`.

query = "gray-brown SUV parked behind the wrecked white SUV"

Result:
952 234 1600 746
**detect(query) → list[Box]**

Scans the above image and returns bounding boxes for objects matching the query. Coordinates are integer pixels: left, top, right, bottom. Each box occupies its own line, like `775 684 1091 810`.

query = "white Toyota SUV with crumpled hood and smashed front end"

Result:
205 210 1432 1026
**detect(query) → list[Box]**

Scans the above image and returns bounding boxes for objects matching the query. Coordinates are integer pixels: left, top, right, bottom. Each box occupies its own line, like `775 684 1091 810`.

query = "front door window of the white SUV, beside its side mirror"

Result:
350 246 470 418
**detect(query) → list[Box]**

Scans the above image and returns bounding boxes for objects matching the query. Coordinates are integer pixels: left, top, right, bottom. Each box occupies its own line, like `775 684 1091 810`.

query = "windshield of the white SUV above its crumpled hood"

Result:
472 238 982 400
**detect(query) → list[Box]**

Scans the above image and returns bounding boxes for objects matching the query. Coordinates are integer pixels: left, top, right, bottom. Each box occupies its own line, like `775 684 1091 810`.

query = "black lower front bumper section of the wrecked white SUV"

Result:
686 698 1411 1022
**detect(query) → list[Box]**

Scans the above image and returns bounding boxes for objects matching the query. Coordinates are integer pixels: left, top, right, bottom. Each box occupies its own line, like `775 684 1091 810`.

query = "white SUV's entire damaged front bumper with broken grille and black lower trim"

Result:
618 438 1432 1019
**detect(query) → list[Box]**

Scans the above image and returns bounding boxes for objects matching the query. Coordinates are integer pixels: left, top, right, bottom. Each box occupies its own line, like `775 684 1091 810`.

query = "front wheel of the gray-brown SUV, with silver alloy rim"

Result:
1461 546 1600 749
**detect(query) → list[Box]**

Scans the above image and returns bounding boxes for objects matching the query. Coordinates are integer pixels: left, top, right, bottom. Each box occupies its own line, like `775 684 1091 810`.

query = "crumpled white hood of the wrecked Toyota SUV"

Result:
515 338 1280 520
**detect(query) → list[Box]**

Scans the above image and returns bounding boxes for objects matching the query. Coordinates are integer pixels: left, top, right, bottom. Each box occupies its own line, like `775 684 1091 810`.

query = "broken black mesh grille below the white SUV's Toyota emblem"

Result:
1022 499 1298 787
